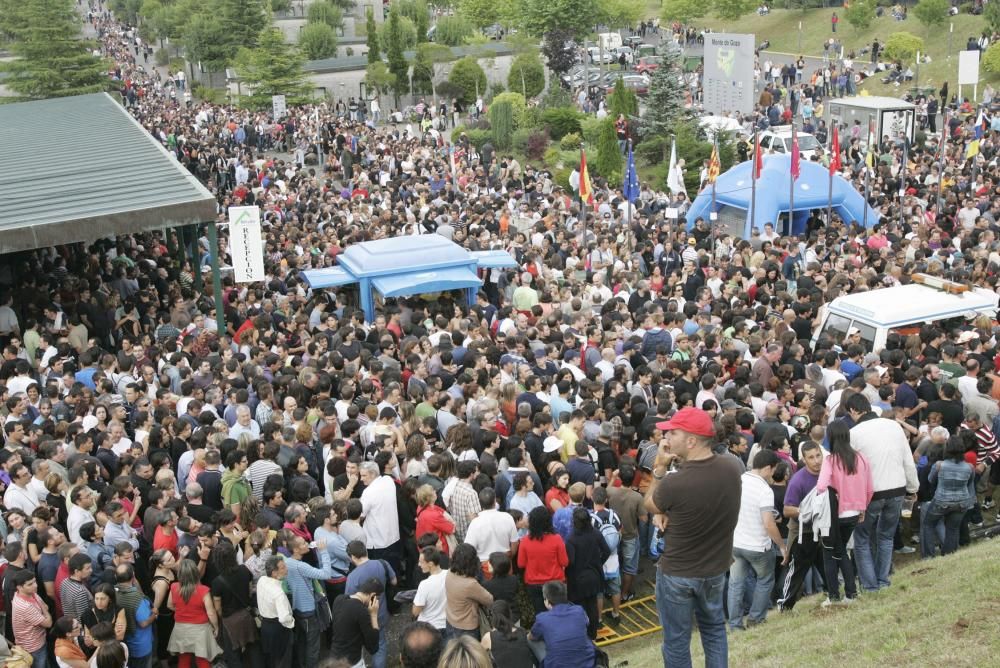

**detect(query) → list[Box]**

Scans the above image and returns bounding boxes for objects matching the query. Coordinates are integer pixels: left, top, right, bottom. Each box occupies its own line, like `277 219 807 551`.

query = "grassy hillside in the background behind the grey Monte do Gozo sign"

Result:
684 8 991 97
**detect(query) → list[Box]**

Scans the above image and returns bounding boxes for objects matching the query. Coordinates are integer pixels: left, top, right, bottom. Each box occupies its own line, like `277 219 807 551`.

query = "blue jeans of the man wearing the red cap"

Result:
656 569 729 668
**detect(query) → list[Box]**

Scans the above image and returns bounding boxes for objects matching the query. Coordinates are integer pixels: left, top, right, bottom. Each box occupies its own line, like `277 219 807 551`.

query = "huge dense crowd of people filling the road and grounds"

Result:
0 1 1000 668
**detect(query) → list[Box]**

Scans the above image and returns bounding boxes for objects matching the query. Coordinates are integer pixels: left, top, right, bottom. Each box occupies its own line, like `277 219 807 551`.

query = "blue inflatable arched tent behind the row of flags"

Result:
687 155 879 239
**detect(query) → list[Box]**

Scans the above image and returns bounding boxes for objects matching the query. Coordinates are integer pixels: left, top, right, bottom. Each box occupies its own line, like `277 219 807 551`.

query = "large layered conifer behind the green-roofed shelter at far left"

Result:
0 0 113 100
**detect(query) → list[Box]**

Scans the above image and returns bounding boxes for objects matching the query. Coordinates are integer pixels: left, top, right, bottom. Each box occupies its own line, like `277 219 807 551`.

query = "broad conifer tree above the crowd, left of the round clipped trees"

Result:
236 28 311 109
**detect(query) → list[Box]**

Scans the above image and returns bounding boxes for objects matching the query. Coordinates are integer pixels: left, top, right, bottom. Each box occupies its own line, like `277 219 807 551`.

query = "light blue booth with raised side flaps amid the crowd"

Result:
302 234 517 322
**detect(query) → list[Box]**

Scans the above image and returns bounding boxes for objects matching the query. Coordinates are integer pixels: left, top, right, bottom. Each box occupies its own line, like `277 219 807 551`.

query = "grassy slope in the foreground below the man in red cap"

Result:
608 540 1000 668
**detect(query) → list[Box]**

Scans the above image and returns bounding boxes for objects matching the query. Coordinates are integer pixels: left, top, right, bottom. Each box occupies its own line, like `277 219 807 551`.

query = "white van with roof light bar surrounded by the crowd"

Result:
812 274 1000 352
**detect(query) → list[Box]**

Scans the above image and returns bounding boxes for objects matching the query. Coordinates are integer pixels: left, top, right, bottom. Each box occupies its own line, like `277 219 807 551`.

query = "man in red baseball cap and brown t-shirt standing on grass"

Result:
646 408 743 666
